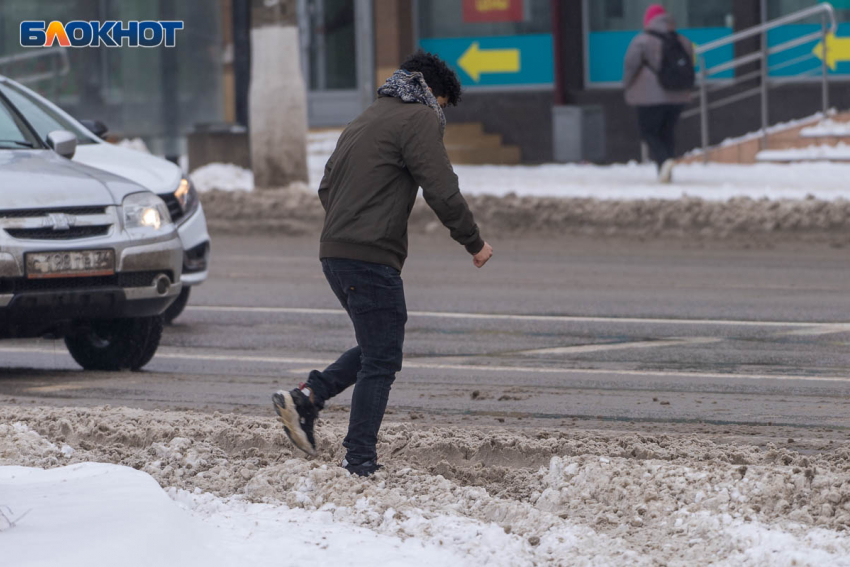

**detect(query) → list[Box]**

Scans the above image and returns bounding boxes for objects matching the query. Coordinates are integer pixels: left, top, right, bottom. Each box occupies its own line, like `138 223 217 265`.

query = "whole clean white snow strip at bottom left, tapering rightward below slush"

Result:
0 463 461 567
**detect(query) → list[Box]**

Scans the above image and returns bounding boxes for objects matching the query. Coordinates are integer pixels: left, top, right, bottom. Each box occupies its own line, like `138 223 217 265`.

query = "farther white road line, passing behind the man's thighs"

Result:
186 305 850 331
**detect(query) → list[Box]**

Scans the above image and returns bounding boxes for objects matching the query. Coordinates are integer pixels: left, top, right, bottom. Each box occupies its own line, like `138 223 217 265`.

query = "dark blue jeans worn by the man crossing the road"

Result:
307 258 407 465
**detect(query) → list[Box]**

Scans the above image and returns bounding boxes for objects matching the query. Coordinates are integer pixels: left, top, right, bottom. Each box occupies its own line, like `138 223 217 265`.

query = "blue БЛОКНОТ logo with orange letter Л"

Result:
21 20 183 47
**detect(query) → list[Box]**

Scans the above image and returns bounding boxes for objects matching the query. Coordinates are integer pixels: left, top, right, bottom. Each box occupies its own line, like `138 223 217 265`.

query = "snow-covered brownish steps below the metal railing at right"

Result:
680 112 850 164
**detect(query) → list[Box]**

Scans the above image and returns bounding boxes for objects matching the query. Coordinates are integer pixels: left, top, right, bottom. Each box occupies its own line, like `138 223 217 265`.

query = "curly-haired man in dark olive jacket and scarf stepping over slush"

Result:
272 51 493 476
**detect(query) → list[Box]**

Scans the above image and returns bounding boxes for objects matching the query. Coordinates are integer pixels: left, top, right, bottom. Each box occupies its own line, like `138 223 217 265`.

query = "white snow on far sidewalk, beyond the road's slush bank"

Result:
192 131 850 201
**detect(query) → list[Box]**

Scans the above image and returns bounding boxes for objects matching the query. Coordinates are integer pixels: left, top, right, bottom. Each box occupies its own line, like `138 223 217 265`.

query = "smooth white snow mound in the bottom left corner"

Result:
0 463 229 567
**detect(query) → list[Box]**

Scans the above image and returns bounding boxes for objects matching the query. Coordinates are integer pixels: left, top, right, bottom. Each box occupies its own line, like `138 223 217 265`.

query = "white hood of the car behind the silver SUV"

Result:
74 143 183 194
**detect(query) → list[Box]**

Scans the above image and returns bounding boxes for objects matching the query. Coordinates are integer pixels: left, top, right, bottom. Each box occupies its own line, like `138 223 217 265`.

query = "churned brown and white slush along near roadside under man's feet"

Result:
0 407 850 566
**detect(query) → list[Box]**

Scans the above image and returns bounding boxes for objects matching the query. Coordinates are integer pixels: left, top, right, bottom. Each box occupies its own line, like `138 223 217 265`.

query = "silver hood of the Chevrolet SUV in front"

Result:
0 150 145 210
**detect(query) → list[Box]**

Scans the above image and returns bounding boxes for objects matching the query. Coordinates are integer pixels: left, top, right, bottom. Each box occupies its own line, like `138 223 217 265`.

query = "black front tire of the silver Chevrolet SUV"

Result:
65 316 163 371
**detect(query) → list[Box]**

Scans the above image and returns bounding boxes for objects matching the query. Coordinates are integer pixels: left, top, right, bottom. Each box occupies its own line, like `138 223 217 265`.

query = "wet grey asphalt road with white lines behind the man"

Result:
0 236 850 439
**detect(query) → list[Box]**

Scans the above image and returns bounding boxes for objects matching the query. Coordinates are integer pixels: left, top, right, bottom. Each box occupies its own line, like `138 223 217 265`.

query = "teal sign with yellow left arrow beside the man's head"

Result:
419 34 555 88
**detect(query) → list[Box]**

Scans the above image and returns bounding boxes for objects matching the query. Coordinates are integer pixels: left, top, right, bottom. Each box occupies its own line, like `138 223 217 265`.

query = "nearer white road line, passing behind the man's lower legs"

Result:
0 347 850 382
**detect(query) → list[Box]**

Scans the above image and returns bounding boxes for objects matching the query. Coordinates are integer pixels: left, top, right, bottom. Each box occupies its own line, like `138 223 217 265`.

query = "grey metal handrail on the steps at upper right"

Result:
683 2 838 162
